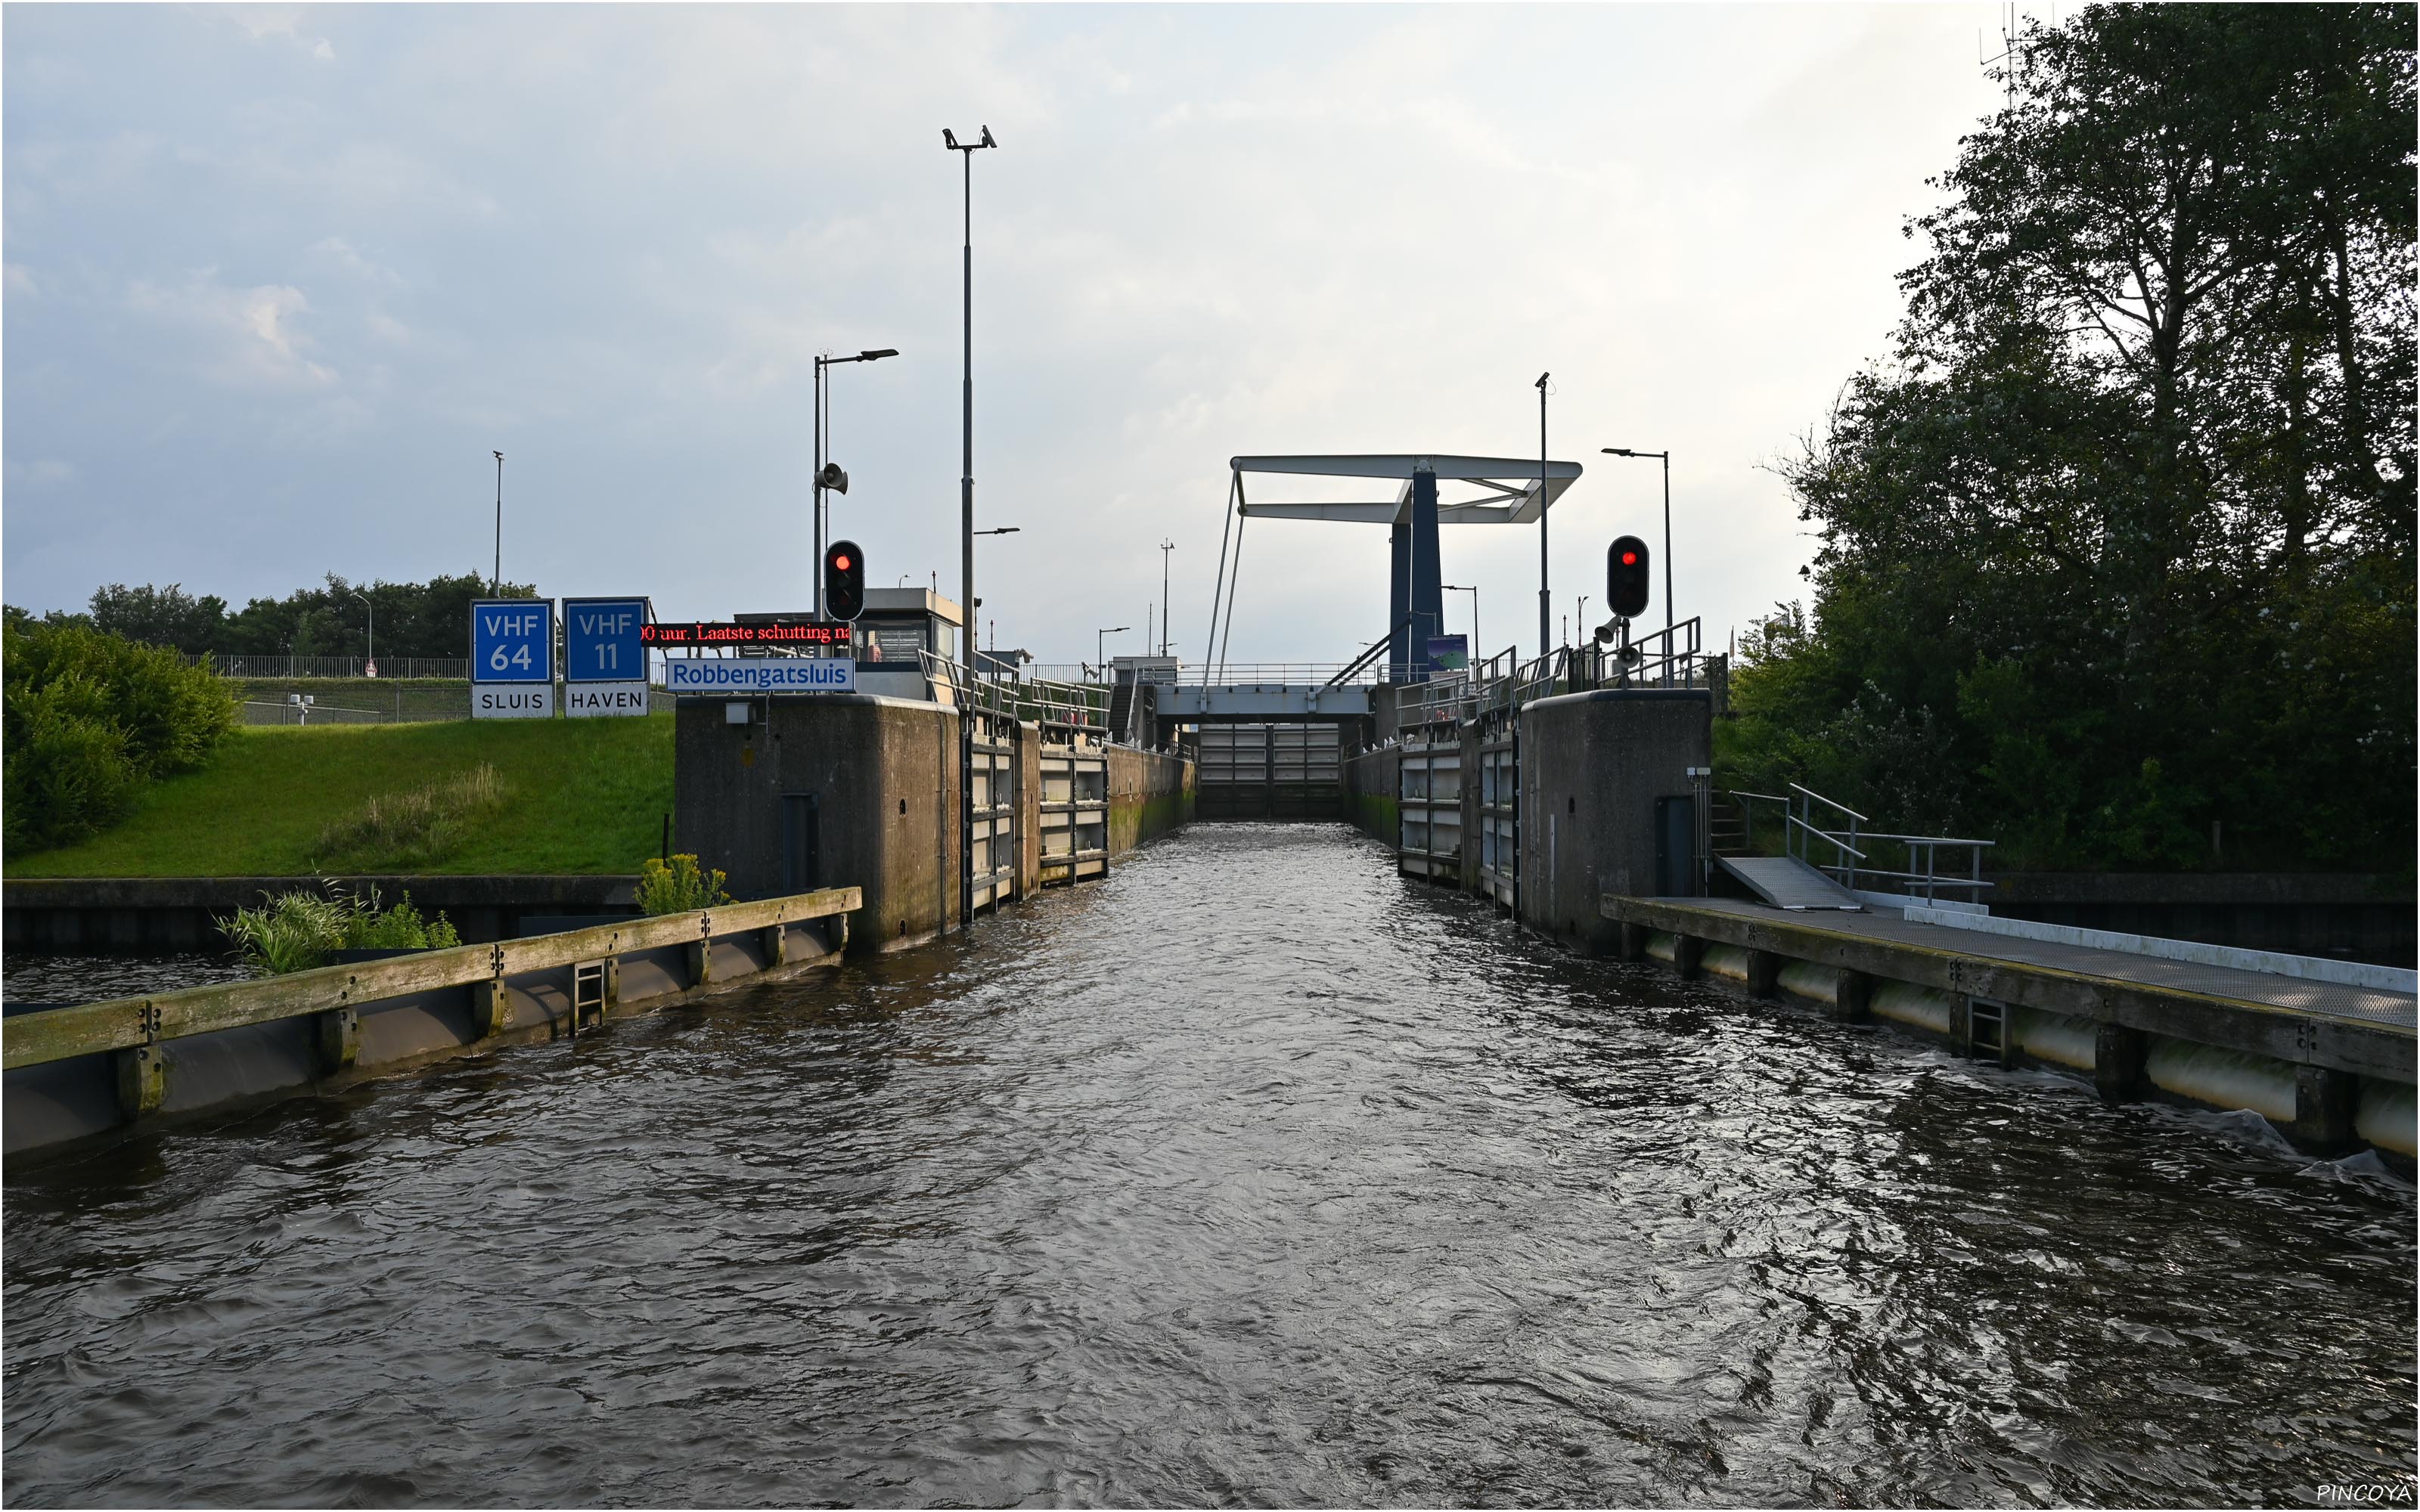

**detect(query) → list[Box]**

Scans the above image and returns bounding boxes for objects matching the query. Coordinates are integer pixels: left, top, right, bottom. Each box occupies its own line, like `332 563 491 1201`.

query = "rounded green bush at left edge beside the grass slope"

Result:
0 609 234 851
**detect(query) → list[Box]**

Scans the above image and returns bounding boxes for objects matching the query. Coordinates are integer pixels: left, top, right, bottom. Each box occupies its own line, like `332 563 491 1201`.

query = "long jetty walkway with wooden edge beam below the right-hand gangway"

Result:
1602 893 2420 1081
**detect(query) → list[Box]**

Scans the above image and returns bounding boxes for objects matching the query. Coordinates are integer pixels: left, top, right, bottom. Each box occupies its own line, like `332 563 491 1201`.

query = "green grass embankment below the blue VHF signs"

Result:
8 714 673 875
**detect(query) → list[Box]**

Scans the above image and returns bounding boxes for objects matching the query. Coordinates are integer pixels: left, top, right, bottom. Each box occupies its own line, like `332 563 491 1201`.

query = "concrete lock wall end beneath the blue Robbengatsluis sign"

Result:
673 694 963 951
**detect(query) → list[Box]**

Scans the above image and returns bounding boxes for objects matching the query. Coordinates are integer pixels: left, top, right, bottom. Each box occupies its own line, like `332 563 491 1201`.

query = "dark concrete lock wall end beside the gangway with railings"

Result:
1520 687 1714 951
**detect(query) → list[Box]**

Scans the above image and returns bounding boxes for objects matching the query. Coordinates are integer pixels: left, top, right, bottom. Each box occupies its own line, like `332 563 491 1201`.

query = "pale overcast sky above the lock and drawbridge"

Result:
0 2 1999 661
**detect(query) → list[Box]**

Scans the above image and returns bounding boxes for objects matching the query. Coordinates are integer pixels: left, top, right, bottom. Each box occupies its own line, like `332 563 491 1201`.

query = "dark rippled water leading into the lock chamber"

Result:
5 825 2415 1504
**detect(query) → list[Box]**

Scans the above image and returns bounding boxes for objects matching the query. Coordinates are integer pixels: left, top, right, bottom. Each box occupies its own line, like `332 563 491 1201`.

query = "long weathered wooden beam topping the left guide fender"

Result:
0 888 864 1072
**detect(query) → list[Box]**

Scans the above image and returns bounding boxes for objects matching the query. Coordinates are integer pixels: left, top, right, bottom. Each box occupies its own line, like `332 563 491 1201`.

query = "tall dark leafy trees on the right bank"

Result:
1726 5 2415 871
